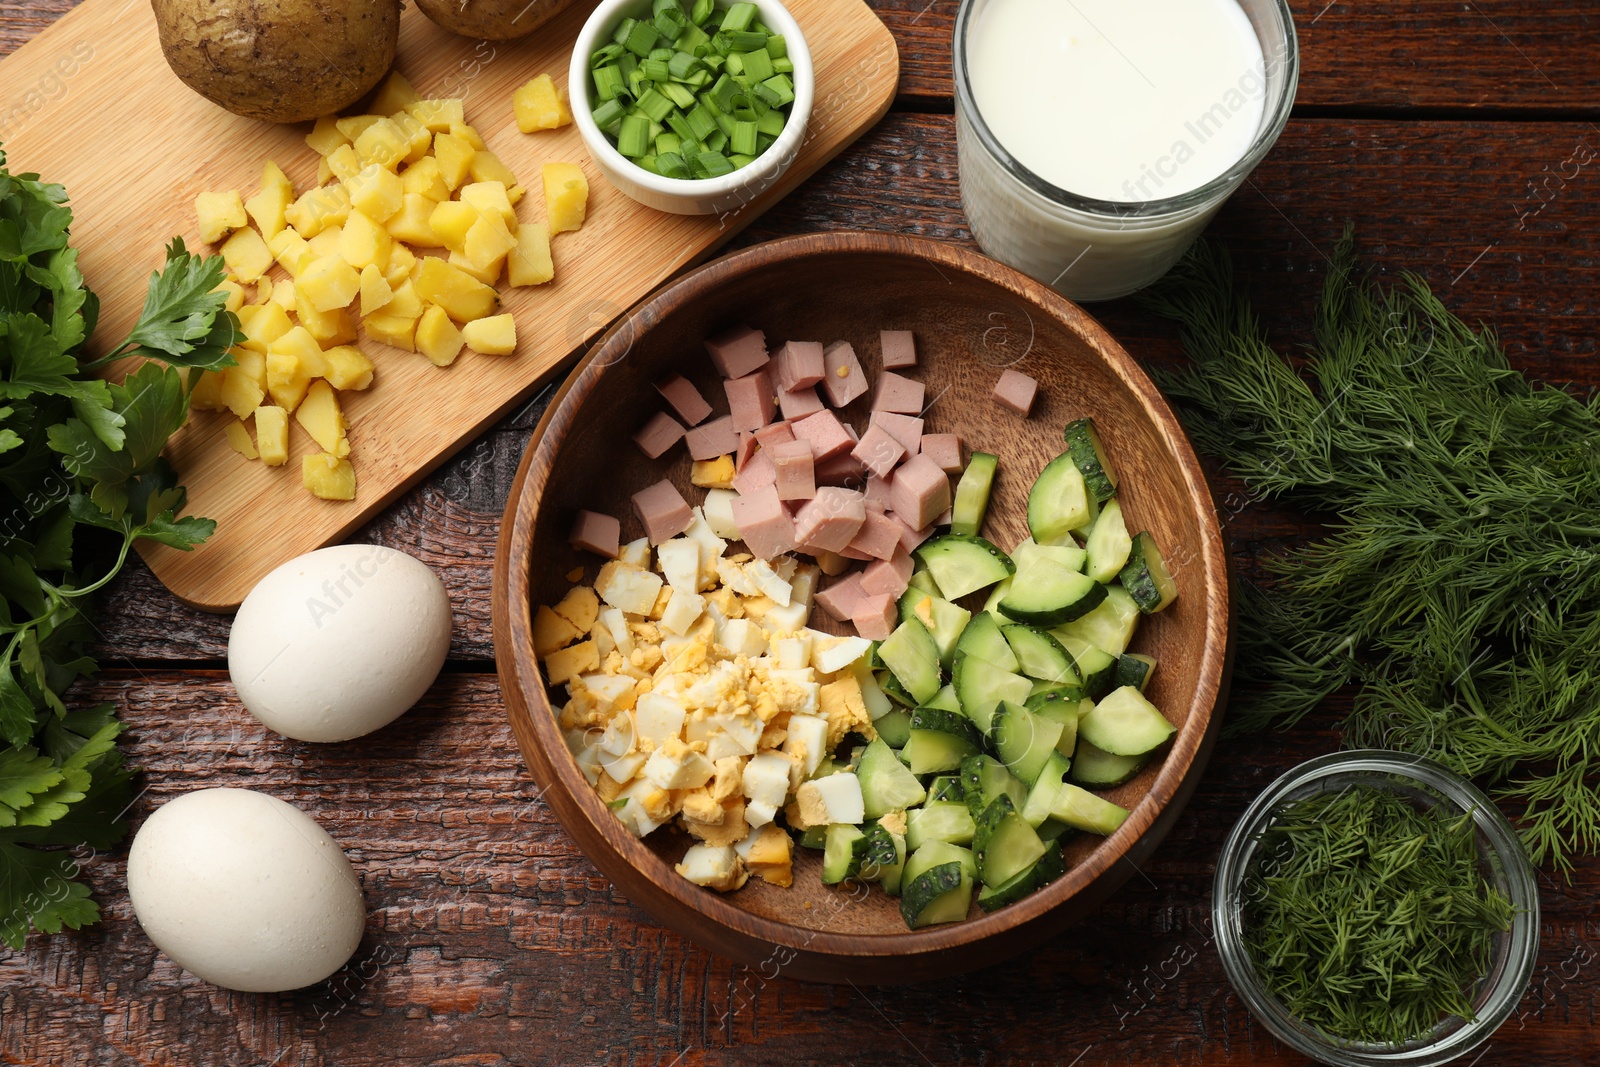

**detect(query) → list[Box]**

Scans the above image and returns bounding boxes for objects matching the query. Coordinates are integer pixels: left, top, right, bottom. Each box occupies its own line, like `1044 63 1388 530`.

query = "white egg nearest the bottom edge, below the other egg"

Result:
128 789 366 993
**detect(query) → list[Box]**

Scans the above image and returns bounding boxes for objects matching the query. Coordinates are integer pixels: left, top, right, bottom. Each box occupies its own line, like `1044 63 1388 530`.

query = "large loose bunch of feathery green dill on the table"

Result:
1147 229 1600 869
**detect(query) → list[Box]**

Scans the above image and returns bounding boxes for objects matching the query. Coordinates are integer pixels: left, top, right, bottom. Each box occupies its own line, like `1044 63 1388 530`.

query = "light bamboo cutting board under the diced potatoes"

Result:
0 0 899 611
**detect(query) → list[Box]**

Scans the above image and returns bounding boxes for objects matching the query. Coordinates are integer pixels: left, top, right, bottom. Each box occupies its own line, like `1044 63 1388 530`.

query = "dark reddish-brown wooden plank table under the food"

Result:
0 0 1600 1067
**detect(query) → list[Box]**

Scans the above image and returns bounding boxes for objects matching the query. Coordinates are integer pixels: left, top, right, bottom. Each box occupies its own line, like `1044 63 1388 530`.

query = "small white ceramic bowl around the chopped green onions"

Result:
566 0 816 214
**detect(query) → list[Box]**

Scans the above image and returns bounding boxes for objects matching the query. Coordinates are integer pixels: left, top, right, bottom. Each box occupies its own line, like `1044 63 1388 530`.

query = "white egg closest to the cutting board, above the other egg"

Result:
227 544 450 741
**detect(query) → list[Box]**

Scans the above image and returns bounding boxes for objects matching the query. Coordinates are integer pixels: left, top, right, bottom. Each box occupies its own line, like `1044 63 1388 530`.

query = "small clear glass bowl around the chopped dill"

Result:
1211 749 1539 1067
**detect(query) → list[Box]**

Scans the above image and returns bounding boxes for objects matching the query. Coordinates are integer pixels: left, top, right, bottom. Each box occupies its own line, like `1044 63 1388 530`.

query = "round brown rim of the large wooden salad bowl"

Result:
493 232 1232 981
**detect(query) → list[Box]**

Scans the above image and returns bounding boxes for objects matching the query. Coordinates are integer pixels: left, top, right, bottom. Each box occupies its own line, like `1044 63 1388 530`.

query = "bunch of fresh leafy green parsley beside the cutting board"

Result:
0 152 238 949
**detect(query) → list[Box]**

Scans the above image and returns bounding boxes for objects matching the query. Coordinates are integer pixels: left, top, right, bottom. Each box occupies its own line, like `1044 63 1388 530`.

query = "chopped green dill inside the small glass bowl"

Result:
1242 787 1515 1045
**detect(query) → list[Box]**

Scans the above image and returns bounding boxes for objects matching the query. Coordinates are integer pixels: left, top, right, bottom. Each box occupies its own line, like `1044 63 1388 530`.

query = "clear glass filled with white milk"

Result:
955 0 1299 301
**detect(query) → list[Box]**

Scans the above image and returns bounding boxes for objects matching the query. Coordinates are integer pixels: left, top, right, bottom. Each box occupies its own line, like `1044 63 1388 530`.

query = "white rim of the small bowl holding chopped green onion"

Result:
566 0 816 200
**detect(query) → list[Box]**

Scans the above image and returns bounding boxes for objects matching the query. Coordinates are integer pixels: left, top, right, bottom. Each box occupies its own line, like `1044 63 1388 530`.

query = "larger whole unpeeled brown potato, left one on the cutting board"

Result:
150 0 400 122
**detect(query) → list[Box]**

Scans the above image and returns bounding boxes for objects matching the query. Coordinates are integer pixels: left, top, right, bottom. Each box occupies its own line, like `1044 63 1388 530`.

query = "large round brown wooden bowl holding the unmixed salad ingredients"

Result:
494 234 1229 984
